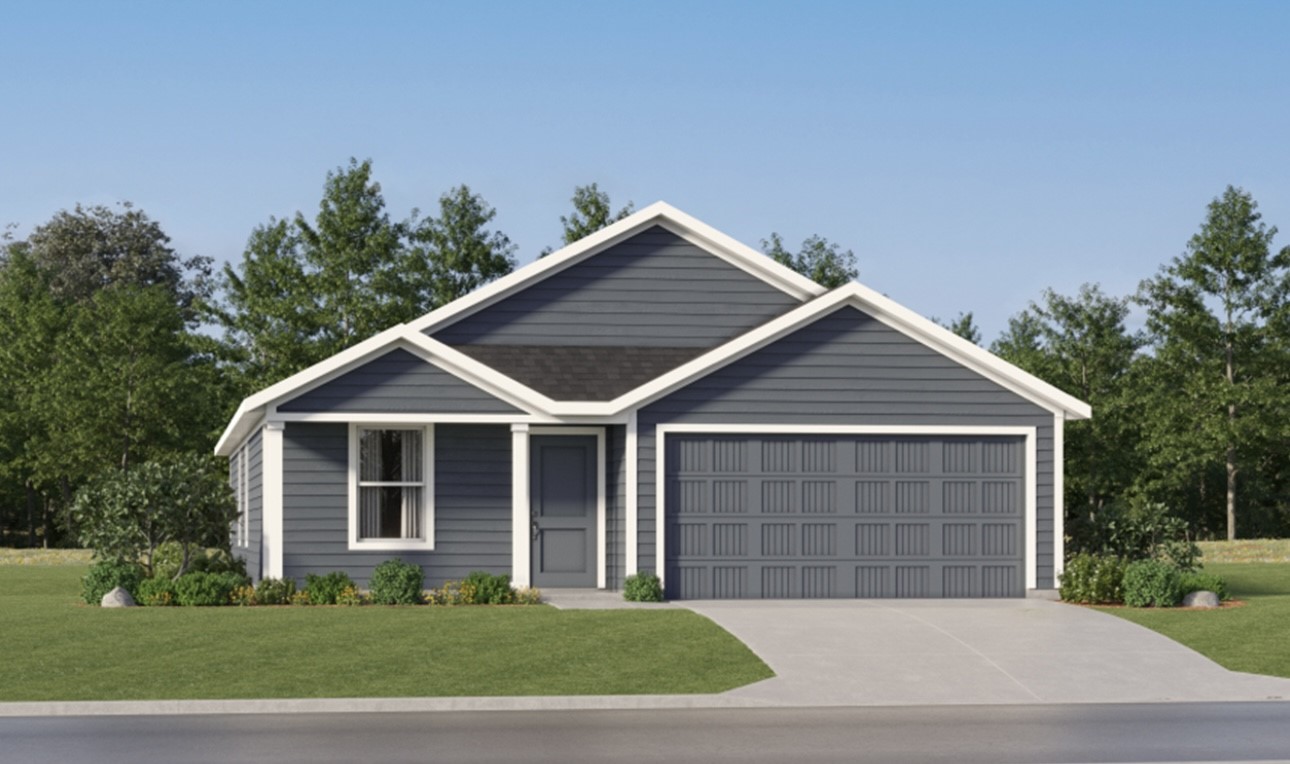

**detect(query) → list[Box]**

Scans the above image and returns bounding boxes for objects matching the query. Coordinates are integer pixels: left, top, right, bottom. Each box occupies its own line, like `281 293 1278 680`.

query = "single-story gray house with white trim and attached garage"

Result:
215 203 1090 599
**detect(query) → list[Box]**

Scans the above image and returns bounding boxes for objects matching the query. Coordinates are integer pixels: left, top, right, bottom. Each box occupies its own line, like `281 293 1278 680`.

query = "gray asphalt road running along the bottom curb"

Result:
0 702 1290 764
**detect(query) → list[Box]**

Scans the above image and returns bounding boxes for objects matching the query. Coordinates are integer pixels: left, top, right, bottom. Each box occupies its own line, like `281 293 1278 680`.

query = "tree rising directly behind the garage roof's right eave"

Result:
991 284 1142 548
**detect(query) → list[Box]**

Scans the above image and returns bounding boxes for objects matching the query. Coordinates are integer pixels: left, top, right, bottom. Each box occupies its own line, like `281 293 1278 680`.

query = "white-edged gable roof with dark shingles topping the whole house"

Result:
215 203 1093 456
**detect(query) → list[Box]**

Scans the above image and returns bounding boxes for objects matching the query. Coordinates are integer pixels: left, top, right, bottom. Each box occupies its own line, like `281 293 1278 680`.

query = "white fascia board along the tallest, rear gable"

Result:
408 201 826 332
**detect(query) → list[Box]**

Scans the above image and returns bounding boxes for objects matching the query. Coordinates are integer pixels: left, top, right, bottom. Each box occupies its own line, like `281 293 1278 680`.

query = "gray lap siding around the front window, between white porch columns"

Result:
283 422 511 587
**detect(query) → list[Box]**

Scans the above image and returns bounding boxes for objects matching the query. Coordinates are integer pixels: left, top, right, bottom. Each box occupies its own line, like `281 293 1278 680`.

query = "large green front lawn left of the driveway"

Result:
0 564 773 701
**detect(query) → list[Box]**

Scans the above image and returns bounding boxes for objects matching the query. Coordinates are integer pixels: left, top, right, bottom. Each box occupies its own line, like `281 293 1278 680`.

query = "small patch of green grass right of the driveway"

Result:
1106 556 1290 678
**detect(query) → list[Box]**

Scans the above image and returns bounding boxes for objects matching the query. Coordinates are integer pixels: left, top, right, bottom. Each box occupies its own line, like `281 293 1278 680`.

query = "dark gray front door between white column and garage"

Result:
529 435 596 588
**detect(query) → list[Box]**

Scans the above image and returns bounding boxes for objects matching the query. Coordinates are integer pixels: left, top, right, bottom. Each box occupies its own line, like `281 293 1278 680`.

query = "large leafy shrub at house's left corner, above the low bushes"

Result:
72 454 237 578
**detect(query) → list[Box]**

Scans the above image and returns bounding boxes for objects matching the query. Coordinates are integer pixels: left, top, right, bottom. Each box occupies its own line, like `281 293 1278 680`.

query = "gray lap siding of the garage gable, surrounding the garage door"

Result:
637 308 1054 588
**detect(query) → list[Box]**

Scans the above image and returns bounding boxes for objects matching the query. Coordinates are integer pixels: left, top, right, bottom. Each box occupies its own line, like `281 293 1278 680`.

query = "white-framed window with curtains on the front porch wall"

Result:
350 426 433 548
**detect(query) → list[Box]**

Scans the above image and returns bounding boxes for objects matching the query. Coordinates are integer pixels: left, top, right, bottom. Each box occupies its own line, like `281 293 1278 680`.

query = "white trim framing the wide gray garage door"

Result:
654 423 1037 590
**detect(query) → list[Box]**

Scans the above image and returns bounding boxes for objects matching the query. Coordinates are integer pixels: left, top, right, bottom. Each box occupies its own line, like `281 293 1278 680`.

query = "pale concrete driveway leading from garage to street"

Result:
679 599 1290 706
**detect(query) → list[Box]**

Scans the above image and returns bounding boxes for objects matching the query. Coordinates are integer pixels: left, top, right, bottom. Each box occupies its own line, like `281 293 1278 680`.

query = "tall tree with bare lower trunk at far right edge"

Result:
1138 186 1290 539
